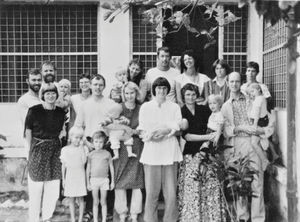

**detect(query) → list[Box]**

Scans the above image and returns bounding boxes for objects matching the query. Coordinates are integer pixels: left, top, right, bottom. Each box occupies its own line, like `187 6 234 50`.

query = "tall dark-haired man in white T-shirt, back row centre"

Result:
146 47 180 102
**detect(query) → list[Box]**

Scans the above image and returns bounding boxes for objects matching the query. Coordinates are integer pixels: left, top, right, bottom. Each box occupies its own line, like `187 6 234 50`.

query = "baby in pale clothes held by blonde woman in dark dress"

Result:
100 104 136 160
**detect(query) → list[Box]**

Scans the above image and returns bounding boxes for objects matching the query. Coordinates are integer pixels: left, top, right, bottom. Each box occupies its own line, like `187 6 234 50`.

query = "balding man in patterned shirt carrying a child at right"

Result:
221 72 268 222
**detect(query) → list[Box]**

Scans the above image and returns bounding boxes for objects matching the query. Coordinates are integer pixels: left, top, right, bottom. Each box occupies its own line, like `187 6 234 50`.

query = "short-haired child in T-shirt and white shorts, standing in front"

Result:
86 131 114 222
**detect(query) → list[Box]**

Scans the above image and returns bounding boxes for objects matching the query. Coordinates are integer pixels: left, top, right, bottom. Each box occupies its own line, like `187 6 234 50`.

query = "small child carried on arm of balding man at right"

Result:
248 83 269 170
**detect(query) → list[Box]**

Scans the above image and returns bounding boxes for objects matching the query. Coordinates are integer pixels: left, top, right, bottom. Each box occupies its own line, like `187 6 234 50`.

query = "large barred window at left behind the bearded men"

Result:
0 5 98 102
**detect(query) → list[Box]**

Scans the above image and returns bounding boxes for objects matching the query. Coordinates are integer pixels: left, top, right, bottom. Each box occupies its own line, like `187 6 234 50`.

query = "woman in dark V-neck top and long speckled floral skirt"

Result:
178 83 225 222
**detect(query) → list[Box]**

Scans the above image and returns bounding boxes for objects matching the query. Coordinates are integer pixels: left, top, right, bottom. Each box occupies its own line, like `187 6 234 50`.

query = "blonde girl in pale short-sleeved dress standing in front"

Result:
60 127 87 222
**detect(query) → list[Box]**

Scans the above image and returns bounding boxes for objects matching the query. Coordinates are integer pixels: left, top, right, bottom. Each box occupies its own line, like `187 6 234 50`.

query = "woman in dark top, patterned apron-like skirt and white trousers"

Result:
25 83 65 222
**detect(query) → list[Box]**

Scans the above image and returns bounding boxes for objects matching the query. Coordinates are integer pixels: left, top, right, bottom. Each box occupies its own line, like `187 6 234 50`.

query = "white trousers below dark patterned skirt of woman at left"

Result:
28 175 60 222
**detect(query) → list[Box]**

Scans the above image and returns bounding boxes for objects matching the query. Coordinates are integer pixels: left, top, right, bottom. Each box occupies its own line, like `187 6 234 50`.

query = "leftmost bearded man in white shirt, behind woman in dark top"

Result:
18 69 42 156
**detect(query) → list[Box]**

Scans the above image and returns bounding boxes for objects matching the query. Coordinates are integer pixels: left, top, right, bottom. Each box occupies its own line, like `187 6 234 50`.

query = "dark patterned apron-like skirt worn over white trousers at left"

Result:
28 138 61 181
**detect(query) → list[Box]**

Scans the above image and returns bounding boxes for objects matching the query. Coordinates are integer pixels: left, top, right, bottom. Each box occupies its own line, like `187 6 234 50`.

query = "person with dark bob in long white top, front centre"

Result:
138 77 182 222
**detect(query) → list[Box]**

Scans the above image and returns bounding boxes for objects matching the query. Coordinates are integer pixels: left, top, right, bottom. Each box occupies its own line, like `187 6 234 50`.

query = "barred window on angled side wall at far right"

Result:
263 21 288 108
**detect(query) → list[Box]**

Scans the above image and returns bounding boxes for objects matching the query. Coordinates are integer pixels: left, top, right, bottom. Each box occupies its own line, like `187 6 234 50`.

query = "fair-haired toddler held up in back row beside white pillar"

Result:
110 70 128 103
